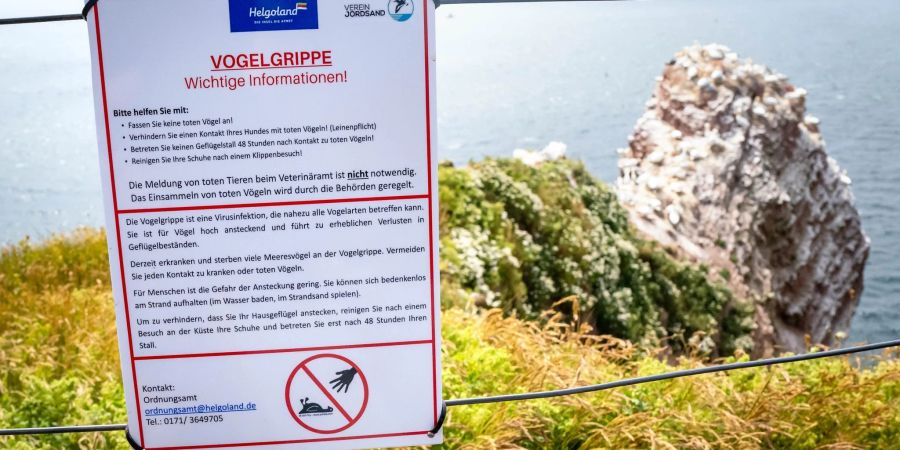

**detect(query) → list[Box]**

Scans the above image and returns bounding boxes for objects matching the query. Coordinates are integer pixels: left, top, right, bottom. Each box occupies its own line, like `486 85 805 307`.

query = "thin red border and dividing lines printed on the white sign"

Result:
93 0 440 450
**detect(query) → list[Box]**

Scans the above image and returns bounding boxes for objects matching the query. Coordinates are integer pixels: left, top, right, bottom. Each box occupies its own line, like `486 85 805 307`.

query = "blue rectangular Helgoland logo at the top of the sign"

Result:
228 0 319 33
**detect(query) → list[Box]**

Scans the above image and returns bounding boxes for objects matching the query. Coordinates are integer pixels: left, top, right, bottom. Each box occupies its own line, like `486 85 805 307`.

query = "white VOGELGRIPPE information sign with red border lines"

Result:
88 0 442 449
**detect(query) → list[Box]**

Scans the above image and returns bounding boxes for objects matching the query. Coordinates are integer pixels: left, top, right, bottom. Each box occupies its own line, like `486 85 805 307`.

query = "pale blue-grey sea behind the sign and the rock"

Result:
0 0 900 342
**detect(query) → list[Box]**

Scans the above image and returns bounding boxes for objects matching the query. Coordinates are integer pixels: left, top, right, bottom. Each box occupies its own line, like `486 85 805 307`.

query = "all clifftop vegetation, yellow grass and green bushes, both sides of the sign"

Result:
0 160 900 450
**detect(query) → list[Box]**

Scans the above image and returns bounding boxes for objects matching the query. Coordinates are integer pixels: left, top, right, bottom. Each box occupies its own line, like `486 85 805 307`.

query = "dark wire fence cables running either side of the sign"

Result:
0 0 900 442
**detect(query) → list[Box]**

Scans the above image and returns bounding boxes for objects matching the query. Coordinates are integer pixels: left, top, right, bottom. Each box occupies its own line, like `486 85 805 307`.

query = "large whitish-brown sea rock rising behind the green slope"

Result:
618 45 869 355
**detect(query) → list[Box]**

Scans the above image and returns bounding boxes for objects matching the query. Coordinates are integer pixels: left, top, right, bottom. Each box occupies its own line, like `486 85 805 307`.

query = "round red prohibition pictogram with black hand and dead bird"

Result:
284 353 369 434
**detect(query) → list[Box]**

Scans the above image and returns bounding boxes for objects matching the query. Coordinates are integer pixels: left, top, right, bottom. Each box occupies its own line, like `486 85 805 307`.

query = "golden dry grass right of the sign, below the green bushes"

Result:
444 310 900 449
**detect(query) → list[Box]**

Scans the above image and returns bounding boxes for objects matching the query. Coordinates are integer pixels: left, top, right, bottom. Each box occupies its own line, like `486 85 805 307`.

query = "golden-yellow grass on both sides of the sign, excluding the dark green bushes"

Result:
0 230 900 449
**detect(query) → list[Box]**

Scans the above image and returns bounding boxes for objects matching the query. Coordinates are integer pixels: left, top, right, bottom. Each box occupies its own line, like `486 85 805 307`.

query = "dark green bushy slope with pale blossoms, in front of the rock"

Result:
439 159 752 355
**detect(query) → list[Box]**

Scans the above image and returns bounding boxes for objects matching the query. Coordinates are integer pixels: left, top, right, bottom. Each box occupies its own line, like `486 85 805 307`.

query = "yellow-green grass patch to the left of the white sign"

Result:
0 230 127 449
